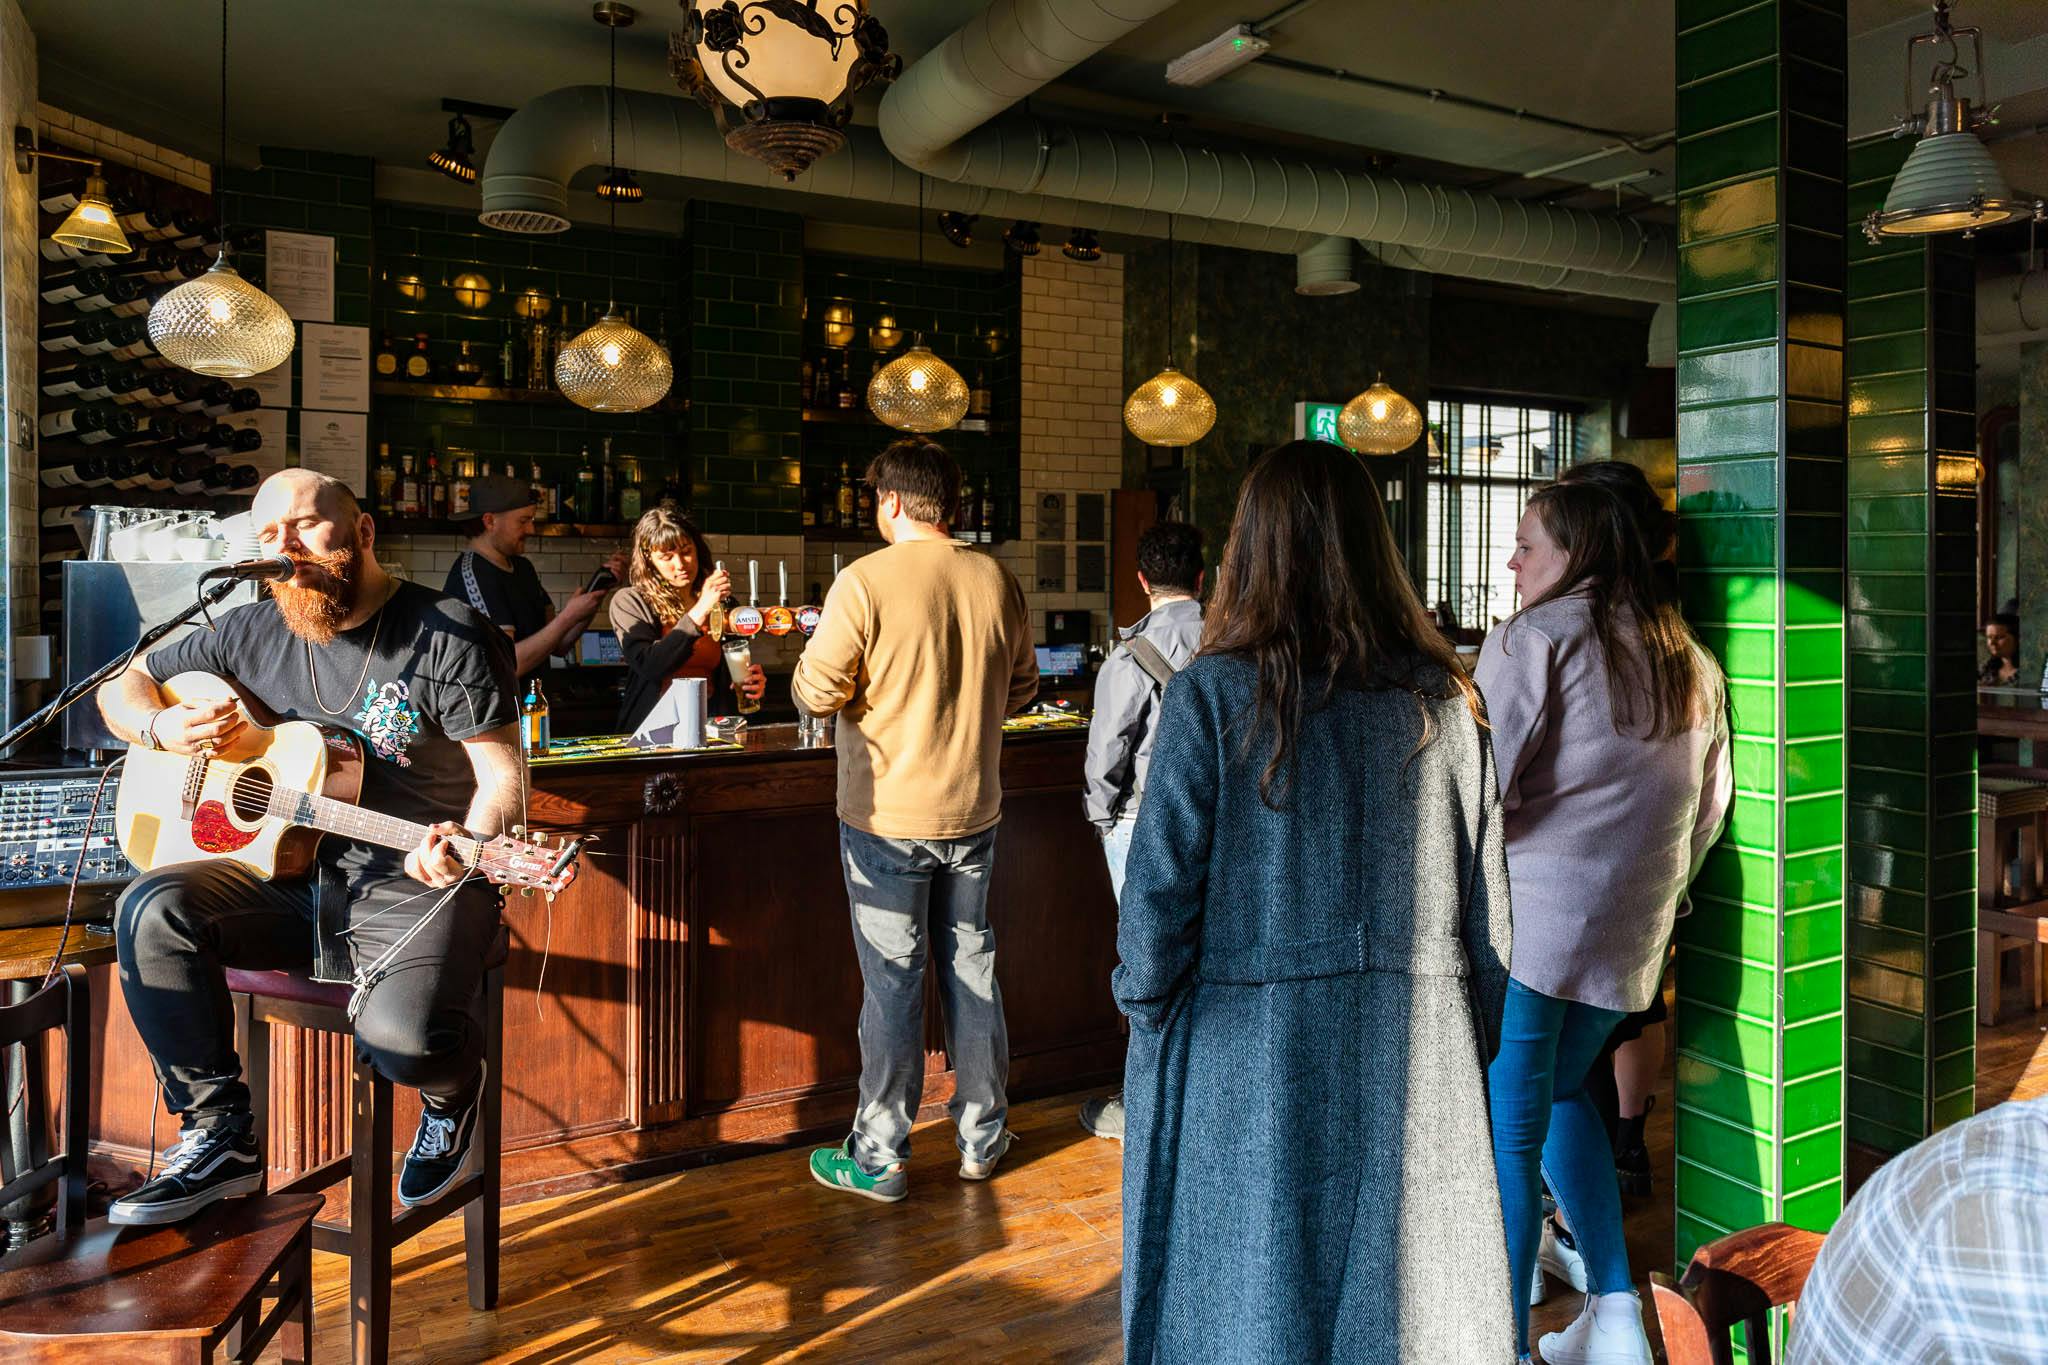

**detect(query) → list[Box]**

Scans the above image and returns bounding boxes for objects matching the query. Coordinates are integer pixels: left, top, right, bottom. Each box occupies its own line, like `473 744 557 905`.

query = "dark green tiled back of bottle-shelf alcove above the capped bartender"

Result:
371 203 688 517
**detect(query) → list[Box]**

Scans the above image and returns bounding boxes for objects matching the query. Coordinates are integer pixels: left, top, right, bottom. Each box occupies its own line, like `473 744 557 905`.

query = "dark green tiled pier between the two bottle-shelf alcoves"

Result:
684 201 803 536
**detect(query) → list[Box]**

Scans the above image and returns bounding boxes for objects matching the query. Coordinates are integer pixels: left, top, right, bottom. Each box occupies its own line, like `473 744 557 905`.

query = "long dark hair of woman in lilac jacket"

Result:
1522 479 1718 739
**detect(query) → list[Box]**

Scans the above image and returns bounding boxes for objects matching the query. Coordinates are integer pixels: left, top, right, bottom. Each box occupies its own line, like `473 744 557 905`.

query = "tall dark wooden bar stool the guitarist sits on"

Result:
227 925 510 1365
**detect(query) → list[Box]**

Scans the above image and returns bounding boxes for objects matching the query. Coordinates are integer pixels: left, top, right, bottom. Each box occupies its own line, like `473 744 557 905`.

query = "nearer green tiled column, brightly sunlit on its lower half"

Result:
1675 0 1847 1265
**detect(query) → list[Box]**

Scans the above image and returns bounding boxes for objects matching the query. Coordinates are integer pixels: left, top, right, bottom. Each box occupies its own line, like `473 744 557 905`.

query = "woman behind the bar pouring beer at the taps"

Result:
610 508 768 731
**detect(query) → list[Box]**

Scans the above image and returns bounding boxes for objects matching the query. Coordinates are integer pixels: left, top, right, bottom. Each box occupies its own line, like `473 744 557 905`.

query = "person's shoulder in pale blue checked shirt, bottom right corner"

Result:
1786 1099 2048 1365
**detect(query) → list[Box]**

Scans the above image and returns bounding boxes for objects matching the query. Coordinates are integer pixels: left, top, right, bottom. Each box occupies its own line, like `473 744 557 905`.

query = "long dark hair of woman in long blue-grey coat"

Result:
1202 440 1479 810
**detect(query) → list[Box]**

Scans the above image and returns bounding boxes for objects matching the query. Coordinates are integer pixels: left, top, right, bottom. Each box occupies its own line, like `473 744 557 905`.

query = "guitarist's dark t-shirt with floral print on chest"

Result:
143 583 518 872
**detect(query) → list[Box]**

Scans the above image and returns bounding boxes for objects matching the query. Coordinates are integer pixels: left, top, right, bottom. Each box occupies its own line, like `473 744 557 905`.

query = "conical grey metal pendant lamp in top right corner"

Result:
1864 0 2042 244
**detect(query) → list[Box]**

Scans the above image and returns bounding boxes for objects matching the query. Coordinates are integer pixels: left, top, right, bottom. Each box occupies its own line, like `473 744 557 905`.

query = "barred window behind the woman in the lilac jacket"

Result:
1425 399 1575 632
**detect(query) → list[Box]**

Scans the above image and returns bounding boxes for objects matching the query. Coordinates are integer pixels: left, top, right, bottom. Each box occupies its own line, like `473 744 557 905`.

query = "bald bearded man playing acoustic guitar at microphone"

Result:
98 469 524 1224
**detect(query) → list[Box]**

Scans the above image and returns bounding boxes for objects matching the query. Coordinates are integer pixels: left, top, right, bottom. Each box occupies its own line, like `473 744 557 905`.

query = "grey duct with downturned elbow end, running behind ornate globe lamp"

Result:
477 86 1311 252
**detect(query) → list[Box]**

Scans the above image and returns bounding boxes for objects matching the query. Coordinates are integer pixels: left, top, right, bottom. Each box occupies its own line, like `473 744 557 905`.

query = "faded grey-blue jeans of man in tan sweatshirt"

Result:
840 825 1010 1175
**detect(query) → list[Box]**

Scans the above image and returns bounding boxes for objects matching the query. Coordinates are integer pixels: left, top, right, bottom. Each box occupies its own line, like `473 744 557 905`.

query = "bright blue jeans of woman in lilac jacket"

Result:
1487 978 1634 1351
